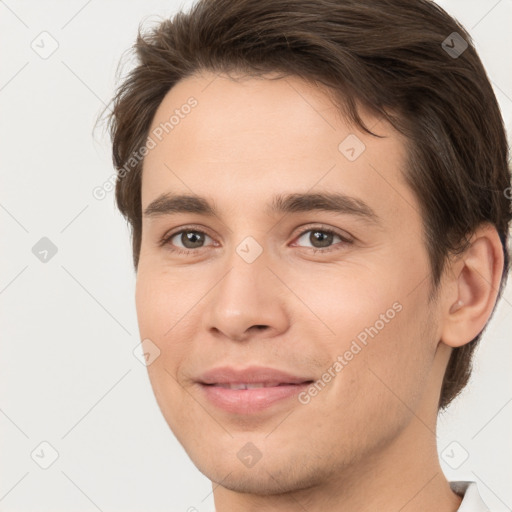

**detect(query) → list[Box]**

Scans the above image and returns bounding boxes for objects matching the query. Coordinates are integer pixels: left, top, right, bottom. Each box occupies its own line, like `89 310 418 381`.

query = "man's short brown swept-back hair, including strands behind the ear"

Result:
109 0 511 408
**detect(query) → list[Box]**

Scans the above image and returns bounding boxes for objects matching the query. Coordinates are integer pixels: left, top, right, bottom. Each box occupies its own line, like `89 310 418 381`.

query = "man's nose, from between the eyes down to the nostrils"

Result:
203 245 289 342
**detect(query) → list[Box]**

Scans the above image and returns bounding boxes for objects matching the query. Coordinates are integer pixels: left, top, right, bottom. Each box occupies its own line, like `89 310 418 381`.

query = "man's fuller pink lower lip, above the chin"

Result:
199 383 310 414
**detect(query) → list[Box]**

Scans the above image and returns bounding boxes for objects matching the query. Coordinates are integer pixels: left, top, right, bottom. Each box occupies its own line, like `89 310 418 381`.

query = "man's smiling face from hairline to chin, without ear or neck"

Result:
136 74 440 494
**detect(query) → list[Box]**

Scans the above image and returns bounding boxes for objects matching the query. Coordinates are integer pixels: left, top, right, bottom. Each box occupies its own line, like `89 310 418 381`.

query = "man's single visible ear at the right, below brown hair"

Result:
441 224 504 348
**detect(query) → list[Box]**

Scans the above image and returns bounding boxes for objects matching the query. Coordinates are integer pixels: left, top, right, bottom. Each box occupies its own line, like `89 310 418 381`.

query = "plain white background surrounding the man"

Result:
0 0 512 512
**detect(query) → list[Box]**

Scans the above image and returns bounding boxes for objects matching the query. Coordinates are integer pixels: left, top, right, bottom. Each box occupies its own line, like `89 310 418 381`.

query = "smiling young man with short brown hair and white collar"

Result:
107 0 511 512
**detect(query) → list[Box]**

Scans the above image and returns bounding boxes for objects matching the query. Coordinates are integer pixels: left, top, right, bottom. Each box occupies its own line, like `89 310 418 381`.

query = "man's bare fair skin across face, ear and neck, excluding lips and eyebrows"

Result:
136 72 503 512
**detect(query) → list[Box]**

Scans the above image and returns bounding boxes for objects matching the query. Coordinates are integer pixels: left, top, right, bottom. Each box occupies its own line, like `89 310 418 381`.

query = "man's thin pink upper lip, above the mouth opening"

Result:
197 366 313 384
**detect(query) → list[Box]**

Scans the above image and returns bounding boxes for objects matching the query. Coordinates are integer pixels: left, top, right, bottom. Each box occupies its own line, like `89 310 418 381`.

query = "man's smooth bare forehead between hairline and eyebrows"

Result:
142 73 415 226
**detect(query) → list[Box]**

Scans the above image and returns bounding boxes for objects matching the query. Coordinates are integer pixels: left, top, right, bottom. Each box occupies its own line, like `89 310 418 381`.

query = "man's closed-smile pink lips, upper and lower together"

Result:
198 366 313 415
